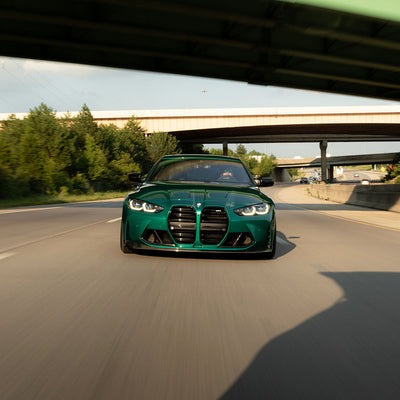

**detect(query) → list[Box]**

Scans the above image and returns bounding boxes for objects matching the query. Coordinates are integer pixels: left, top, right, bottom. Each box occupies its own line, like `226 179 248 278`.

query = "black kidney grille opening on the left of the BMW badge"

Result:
168 206 196 244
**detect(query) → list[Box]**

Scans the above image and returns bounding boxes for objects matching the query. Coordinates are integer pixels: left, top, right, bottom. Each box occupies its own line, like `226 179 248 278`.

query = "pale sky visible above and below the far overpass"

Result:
0 56 400 158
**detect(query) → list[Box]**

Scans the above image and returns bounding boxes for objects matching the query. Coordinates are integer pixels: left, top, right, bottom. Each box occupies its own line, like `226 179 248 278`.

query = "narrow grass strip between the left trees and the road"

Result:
0 191 128 208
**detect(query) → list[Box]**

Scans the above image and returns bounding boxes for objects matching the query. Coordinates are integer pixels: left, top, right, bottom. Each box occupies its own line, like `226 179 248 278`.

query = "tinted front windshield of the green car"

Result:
147 158 253 186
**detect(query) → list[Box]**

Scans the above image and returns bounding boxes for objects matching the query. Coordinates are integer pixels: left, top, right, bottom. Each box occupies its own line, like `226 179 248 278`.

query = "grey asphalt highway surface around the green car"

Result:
0 185 400 400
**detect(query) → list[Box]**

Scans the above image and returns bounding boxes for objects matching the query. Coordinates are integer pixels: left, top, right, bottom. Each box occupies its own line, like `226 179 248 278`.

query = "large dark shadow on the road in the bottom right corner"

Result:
220 272 400 400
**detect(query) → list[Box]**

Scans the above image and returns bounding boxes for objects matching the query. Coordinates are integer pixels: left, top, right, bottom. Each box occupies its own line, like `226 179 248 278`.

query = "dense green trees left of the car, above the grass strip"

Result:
0 103 184 199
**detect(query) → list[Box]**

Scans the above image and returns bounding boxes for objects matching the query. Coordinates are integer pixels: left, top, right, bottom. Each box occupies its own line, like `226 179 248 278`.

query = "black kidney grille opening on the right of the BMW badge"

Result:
200 207 229 245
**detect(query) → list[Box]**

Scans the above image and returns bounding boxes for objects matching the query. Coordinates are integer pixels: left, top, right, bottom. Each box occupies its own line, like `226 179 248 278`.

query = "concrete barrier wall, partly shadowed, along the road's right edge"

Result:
309 183 400 212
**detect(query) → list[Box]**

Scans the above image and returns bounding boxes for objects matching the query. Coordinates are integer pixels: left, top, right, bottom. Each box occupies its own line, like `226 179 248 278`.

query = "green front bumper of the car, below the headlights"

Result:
122 203 276 253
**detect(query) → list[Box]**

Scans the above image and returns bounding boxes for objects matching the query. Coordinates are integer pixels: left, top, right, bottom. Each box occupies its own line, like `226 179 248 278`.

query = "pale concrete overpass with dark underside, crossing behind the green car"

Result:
0 105 400 180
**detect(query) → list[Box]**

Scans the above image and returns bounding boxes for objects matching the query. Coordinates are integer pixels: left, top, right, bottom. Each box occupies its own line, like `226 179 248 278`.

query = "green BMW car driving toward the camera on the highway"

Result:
120 154 276 258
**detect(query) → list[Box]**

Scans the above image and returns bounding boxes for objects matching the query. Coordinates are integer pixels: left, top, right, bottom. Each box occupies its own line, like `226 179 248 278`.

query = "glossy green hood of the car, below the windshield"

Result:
128 183 272 208
